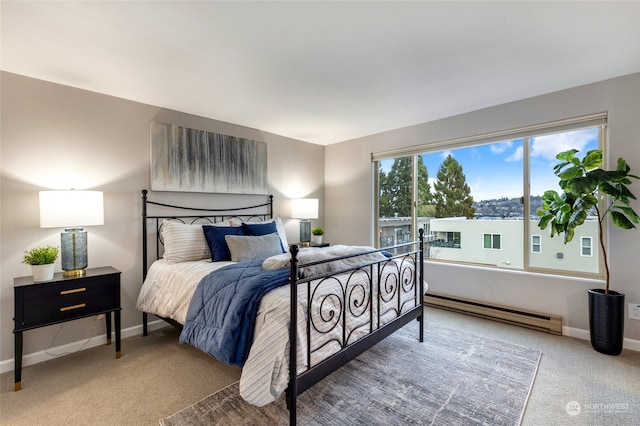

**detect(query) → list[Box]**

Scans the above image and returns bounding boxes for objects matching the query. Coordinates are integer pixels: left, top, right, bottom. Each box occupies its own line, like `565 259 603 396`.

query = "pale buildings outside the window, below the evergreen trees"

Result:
379 217 600 274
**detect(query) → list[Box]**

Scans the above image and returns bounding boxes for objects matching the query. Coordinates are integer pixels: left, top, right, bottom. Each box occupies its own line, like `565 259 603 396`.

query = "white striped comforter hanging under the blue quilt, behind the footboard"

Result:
137 249 426 406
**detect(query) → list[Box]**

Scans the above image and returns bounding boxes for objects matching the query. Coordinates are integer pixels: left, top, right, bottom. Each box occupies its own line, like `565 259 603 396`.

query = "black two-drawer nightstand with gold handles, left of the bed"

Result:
13 266 122 391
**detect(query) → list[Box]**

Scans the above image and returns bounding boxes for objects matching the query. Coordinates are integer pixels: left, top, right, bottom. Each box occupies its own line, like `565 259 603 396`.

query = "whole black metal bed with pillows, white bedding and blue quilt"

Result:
137 190 426 424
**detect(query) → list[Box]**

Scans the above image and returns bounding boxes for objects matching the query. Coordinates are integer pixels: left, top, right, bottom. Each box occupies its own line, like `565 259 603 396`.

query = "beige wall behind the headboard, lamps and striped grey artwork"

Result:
0 72 324 371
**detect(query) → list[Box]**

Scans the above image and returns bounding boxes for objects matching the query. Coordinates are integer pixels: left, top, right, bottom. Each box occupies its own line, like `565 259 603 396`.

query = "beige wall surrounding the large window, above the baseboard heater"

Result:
325 74 640 350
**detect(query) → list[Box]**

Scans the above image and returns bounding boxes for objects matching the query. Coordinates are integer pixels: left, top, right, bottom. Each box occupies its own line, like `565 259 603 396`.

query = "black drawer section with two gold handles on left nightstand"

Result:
16 275 120 329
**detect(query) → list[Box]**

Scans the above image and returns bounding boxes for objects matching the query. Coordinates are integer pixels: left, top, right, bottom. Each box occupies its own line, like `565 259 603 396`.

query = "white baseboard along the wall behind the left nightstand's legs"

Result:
0 319 167 373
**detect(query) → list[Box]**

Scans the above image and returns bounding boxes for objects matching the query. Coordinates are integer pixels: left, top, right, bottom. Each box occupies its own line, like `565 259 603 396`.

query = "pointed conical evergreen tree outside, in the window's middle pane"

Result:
434 154 475 219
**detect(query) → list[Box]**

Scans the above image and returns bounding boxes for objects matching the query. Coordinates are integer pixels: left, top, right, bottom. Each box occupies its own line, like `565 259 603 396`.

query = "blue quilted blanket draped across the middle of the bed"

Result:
180 259 289 367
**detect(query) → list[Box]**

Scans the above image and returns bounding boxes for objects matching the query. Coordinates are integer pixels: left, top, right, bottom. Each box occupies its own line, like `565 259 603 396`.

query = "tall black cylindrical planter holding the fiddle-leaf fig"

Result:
589 288 624 355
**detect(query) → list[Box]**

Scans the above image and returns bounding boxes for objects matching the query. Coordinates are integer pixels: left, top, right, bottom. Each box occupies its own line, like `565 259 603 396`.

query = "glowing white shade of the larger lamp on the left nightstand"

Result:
40 190 104 228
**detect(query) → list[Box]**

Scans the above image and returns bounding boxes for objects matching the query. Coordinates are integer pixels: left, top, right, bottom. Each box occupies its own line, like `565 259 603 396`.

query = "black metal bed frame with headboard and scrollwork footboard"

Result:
142 189 424 425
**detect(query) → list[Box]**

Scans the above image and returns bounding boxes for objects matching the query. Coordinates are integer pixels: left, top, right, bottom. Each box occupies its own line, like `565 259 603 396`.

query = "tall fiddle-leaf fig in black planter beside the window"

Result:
537 149 640 355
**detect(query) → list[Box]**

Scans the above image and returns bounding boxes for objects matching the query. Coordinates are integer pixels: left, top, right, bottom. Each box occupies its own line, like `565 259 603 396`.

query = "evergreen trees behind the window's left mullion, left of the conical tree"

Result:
379 156 432 217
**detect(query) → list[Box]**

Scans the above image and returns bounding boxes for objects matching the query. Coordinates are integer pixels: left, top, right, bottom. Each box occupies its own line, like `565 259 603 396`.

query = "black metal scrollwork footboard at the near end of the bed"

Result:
286 229 424 425
